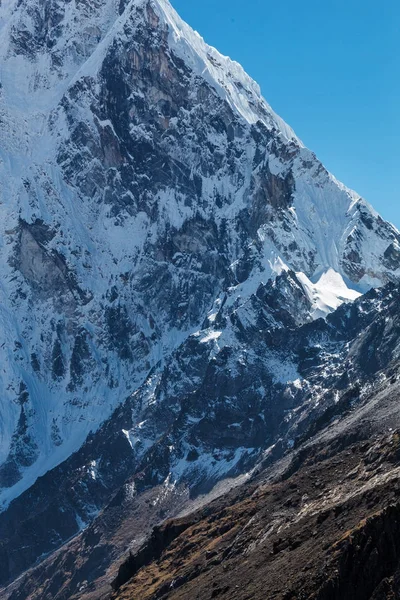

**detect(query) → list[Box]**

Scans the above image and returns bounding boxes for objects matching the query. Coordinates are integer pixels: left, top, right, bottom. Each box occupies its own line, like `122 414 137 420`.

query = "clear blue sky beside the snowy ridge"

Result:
172 0 400 228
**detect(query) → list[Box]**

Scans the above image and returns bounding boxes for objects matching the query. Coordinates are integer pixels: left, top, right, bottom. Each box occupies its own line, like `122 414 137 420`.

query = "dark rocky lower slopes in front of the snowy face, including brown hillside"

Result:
0 276 400 600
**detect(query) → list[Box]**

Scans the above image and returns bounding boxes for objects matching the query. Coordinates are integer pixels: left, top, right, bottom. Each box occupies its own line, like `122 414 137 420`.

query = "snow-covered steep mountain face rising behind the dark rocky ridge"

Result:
0 0 400 505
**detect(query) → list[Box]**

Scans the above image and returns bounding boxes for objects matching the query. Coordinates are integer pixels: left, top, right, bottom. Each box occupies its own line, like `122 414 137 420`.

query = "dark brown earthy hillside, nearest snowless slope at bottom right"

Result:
112 432 400 600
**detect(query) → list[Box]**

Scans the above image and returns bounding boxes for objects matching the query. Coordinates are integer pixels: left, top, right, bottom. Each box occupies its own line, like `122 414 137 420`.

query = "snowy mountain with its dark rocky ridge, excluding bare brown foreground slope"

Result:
0 0 400 598
